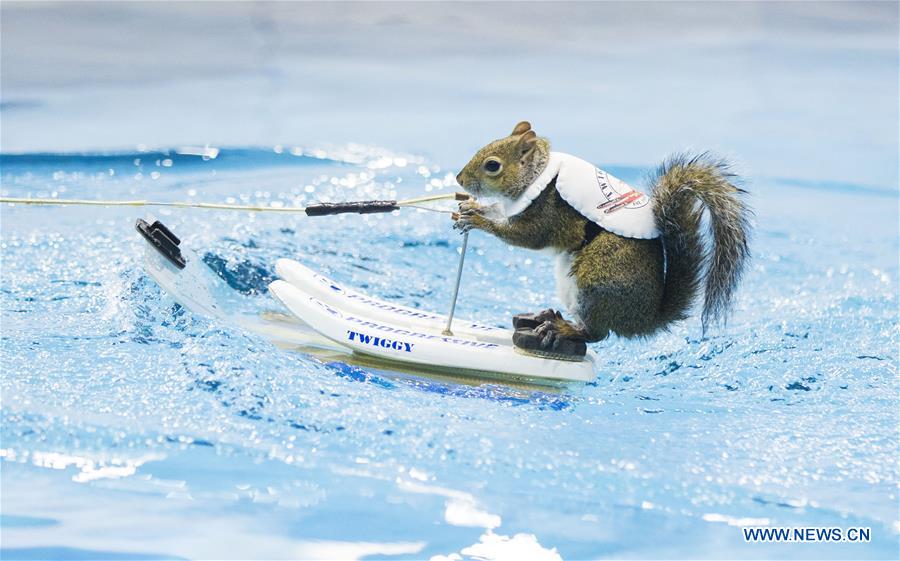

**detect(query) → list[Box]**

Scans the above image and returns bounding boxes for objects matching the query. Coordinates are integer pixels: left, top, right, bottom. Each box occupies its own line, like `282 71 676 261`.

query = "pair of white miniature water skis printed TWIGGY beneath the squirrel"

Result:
142 218 596 387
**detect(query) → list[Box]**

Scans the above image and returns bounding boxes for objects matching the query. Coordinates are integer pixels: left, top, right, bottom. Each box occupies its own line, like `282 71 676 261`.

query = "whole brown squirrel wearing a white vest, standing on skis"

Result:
453 121 752 360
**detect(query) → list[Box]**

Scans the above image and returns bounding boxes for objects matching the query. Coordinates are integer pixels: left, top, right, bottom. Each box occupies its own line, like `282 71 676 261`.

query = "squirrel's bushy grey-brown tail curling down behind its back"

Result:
652 153 752 332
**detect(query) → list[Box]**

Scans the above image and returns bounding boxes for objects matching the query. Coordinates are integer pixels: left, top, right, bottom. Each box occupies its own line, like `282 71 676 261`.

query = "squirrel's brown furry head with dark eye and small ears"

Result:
456 121 550 199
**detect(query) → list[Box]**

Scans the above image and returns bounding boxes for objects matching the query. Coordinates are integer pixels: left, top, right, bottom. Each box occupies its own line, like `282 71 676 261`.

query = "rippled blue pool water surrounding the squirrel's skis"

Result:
0 145 900 560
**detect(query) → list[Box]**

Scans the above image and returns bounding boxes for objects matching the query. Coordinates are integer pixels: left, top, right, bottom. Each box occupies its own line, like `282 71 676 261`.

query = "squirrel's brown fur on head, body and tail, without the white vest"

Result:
455 122 750 341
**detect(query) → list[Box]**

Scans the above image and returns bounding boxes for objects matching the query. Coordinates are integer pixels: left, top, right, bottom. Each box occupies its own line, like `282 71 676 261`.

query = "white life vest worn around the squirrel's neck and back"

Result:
499 152 660 239
